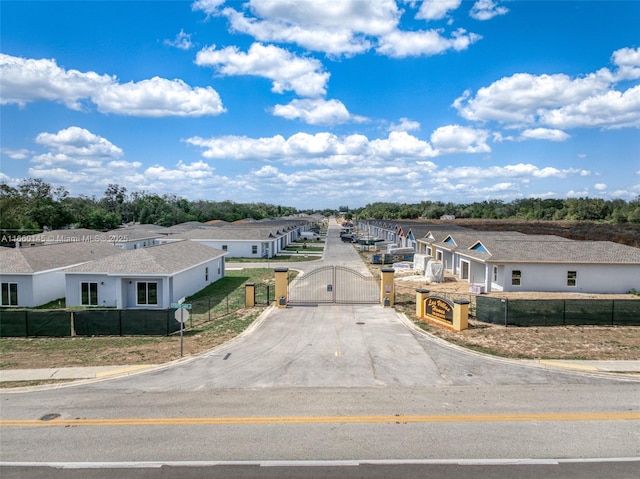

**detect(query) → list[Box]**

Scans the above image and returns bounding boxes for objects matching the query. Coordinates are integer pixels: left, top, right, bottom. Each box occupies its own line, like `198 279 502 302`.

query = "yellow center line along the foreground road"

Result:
0 412 640 427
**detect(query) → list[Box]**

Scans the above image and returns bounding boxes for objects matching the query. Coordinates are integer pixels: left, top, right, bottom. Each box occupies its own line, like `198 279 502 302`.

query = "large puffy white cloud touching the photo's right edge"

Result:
453 48 640 132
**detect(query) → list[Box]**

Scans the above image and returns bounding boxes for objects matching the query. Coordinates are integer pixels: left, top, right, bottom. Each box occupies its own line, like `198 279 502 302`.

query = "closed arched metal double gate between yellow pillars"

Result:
289 266 380 304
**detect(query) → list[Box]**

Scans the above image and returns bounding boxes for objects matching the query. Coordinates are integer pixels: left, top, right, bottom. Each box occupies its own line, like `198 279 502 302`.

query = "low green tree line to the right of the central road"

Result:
349 196 640 223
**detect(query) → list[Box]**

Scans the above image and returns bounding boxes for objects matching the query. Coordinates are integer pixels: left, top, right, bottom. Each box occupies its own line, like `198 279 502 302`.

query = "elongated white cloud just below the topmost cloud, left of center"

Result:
196 43 330 97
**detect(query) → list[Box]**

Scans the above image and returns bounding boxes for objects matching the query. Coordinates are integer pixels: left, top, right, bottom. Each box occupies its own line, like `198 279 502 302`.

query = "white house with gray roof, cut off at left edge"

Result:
0 241 123 308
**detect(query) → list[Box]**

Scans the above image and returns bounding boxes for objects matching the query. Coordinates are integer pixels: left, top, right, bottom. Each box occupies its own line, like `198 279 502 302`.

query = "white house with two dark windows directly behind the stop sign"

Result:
65 241 226 309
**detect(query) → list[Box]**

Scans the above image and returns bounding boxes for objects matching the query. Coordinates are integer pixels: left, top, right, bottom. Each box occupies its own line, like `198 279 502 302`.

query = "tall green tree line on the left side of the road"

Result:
0 178 297 234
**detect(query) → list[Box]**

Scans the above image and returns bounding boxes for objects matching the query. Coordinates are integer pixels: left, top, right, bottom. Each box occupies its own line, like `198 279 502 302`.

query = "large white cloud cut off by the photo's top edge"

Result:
207 0 481 57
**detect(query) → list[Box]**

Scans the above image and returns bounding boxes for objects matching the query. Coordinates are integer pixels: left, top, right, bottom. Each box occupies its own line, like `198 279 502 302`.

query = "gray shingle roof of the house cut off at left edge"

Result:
0 241 124 274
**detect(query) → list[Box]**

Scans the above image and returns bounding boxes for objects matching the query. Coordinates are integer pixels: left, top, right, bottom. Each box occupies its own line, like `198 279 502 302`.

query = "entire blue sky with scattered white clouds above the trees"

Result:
0 0 640 209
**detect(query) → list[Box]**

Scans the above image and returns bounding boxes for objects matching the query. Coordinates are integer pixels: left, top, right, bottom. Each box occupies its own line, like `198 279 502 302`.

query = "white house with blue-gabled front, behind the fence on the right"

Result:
418 230 640 294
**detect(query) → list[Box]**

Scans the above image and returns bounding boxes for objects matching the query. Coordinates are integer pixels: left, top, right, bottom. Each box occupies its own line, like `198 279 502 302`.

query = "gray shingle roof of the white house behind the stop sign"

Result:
68 241 226 275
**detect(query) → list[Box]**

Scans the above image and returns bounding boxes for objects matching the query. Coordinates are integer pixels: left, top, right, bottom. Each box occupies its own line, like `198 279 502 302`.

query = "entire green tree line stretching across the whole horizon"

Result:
0 178 640 233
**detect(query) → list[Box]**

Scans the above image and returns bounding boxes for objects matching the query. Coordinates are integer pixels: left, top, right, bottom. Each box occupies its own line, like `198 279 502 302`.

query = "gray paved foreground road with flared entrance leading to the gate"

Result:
0 219 640 477
